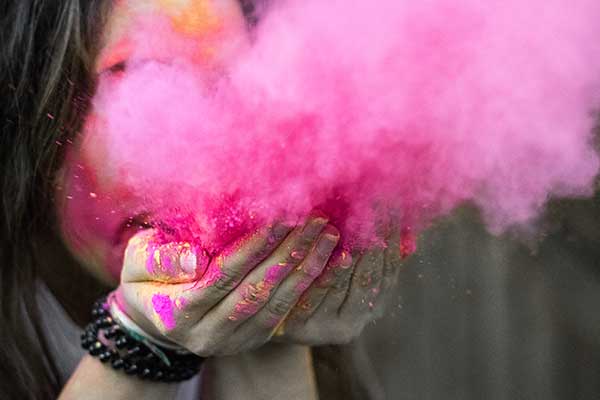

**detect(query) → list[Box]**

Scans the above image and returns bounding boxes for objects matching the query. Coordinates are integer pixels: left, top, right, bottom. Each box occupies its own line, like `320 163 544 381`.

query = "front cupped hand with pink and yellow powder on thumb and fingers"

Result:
114 217 339 356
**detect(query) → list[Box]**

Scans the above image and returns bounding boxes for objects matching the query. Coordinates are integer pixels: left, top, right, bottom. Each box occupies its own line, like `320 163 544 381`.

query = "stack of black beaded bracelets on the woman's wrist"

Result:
81 298 203 382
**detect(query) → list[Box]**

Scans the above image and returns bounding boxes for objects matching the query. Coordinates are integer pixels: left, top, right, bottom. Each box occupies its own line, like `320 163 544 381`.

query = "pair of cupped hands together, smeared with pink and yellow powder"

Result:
111 215 400 356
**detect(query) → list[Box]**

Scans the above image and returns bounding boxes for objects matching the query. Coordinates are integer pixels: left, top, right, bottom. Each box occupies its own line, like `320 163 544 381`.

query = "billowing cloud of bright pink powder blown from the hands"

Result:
88 0 600 253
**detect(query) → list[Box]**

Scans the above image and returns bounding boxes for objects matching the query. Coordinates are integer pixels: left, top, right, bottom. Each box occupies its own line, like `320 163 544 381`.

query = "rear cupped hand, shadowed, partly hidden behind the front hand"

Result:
274 233 402 345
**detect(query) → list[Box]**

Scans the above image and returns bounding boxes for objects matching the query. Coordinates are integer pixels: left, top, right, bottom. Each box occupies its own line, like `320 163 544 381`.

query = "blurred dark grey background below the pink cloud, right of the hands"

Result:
362 195 600 400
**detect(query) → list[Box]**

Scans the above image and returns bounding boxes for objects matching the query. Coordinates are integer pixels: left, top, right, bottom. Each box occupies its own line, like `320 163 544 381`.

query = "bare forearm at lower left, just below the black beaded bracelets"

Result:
59 355 179 400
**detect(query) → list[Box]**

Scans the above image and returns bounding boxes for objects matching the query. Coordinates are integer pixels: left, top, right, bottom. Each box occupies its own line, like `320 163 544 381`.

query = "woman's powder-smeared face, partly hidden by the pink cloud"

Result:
57 0 247 283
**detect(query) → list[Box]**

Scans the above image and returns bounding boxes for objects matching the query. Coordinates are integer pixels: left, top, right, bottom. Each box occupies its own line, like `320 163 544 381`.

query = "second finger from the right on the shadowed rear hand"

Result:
340 248 384 318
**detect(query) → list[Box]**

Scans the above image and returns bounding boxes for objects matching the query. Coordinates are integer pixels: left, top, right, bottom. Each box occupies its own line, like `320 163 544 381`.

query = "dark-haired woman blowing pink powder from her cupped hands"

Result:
0 0 399 399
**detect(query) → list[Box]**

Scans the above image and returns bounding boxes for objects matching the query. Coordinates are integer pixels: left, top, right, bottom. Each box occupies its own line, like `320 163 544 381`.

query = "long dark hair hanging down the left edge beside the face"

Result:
0 0 109 399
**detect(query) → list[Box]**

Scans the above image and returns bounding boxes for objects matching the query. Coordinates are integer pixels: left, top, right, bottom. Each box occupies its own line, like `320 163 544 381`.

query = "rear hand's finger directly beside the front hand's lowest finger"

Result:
286 250 352 324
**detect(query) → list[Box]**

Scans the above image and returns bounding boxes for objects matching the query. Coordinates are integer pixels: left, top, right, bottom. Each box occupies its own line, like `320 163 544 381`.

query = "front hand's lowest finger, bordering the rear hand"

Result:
232 226 340 339
